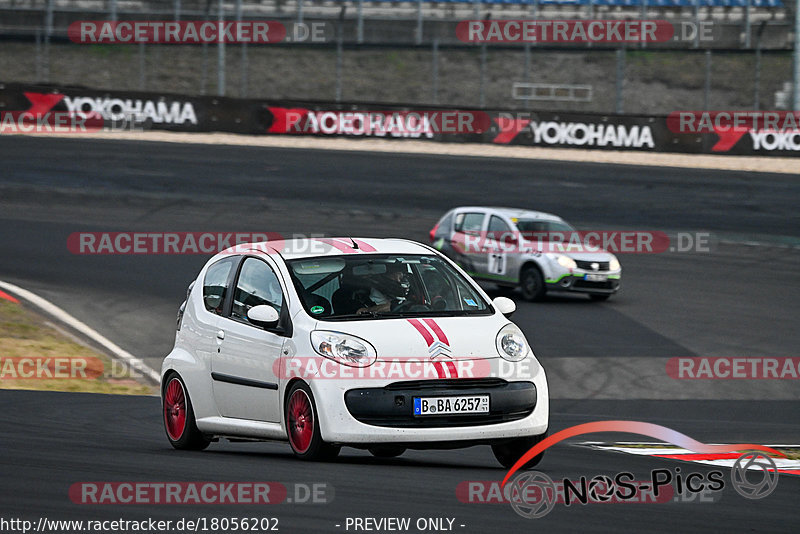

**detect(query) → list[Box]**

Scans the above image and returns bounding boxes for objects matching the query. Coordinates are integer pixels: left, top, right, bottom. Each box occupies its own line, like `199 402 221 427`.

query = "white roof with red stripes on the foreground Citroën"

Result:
222 237 431 260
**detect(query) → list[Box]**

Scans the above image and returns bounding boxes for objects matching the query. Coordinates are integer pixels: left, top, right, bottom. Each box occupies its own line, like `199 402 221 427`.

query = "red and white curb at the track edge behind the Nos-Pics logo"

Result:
579 441 800 475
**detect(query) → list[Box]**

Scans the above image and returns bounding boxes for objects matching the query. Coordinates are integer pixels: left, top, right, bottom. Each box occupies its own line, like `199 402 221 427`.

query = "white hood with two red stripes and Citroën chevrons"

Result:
316 314 509 360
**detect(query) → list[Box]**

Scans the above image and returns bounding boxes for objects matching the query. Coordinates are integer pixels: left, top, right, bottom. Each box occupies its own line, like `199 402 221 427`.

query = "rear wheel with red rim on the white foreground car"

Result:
161 372 211 451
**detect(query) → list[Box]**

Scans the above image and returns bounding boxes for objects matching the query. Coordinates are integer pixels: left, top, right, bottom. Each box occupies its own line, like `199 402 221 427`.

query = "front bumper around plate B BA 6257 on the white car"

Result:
310 360 549 448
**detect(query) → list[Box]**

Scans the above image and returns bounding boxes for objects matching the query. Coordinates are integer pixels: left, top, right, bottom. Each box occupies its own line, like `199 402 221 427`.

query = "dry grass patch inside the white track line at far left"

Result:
0 299 154 395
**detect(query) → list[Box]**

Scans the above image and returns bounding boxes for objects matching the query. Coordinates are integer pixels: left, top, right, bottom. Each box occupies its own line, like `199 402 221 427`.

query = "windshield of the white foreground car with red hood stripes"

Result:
286 255 493 320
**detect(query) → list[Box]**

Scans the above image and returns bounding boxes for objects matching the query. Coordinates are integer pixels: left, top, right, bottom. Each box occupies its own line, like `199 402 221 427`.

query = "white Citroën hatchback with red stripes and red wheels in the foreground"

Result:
161 238 549 467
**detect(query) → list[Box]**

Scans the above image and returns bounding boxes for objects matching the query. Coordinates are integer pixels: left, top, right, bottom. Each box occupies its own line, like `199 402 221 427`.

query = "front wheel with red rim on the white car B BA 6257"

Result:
284 382 341 461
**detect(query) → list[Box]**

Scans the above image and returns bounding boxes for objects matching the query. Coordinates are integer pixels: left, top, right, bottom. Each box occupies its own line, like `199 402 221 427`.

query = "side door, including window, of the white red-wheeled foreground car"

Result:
211 256 287 422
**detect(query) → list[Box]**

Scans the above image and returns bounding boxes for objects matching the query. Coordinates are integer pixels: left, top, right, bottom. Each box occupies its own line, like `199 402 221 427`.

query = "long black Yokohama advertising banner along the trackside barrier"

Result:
0 83 800 156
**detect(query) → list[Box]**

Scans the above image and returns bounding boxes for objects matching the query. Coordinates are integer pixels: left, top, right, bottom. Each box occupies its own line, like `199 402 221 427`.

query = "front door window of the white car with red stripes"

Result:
231 258 283 324
